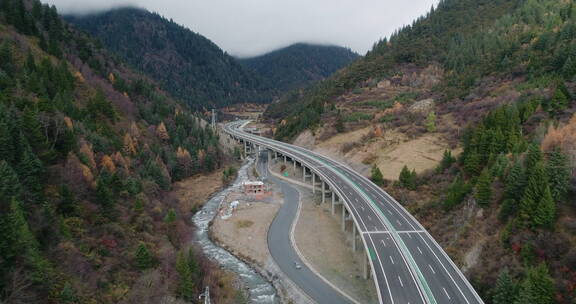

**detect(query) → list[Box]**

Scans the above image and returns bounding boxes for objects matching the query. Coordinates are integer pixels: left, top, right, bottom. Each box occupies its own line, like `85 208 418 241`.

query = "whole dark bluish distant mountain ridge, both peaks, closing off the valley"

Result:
65 7 358 109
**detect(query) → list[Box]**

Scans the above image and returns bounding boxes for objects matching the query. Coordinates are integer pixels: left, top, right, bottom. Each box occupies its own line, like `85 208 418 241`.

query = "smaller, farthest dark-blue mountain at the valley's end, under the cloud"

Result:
240 43 358 93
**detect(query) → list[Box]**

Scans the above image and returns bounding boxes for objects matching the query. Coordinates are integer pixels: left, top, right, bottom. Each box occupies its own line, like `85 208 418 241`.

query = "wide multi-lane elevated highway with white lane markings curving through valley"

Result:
224 121 483 304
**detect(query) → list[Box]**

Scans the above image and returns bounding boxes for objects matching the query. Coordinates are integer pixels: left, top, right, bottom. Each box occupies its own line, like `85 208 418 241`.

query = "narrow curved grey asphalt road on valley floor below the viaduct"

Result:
258 150 352 304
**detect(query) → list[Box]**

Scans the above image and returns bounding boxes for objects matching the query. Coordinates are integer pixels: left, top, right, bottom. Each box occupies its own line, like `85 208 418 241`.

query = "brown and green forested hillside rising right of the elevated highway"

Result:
267 0 576 304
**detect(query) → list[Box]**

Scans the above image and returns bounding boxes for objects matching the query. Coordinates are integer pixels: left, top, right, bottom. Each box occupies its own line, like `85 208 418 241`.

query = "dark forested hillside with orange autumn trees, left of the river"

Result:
0 0 238 303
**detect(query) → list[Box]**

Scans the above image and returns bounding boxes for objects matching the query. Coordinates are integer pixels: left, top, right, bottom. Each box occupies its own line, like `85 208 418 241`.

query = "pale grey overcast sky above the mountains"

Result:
44 0 438 57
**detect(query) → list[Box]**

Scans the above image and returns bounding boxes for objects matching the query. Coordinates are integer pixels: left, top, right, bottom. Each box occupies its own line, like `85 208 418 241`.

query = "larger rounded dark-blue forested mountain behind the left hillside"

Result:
67 8 268 108
